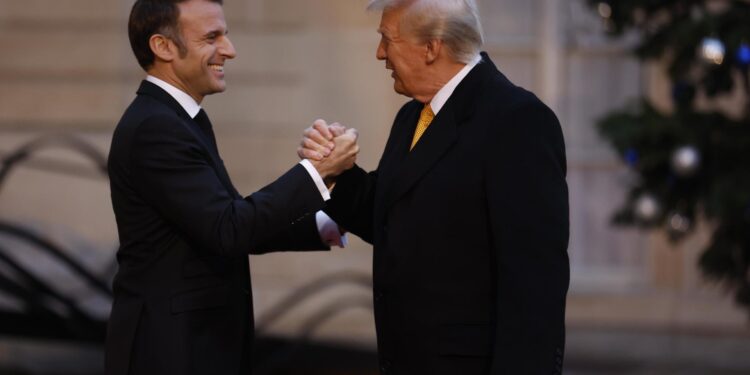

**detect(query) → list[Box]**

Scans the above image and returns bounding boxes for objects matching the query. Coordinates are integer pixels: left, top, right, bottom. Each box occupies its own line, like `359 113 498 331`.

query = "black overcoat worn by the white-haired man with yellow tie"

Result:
326 54 569 375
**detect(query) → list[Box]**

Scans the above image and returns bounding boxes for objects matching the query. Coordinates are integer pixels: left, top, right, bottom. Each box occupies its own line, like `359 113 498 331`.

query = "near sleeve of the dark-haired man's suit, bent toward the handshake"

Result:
130 115 324 256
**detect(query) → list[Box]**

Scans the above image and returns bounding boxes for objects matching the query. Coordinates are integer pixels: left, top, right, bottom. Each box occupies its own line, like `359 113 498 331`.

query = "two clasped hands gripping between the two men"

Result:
304 120 359 187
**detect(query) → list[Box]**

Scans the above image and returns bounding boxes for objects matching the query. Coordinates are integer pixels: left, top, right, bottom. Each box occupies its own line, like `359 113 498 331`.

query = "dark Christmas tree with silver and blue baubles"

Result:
588 0 750 310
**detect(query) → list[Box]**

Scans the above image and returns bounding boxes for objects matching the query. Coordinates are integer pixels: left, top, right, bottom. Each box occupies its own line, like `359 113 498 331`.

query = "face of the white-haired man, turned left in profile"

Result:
377 6 434 101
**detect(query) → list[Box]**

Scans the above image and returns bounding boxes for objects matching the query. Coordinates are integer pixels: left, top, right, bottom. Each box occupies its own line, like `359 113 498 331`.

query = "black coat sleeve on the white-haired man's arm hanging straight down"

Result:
485 100 569 374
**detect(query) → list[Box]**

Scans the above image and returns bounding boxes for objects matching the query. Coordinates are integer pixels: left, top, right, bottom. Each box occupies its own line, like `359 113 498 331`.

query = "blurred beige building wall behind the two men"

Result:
0 0 746 352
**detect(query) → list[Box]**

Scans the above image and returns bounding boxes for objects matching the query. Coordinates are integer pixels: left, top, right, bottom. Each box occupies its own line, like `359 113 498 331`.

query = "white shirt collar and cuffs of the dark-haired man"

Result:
146 75 347 247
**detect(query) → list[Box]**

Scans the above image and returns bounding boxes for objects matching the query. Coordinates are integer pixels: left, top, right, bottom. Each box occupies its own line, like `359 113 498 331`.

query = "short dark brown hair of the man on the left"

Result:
128 0 224 70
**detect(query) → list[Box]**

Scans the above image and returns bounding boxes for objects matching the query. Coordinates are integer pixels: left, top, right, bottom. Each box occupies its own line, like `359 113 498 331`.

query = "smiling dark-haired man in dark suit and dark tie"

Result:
105 0 358 375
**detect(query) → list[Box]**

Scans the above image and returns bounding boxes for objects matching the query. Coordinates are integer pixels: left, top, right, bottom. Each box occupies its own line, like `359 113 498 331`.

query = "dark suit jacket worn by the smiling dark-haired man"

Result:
105 81 325 375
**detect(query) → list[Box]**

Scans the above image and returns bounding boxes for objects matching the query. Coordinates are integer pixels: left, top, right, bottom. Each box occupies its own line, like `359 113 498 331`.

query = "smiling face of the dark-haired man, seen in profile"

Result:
172 0 236 103
